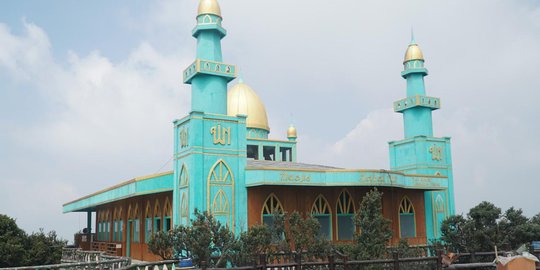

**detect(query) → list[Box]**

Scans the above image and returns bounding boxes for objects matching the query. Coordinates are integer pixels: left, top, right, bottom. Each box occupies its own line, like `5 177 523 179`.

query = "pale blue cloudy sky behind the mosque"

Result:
0 0 540 240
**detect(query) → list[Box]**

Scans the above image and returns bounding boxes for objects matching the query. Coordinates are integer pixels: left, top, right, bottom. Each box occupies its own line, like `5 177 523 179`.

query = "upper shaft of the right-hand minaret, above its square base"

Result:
394 35 441 138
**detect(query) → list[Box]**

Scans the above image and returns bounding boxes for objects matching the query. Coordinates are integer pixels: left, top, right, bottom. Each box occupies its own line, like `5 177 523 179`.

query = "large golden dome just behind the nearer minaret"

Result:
227 82 270 131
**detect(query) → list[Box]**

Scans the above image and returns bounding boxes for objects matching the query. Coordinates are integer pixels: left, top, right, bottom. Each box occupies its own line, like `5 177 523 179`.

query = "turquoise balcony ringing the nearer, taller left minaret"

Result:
183 59 238 84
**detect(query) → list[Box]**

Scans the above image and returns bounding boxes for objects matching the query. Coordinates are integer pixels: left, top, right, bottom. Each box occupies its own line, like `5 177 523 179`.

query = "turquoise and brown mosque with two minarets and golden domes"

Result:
63 0 455 261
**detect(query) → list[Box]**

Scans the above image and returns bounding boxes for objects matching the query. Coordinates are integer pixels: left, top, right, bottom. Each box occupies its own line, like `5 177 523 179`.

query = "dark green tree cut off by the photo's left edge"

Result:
0 214 26 267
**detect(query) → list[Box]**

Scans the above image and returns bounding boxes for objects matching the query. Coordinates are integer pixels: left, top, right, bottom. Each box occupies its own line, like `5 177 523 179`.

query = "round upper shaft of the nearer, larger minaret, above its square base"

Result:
184 0 236 114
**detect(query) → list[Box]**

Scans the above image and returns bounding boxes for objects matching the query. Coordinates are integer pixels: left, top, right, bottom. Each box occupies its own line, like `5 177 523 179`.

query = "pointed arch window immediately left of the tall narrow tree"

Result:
336 190 355 240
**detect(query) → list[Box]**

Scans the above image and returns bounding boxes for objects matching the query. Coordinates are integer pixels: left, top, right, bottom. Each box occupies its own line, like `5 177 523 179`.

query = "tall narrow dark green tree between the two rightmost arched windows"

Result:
354 188 392 260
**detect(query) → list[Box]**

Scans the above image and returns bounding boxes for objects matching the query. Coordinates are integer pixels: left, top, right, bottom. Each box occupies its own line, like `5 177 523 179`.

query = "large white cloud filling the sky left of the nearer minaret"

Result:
0 22 189 240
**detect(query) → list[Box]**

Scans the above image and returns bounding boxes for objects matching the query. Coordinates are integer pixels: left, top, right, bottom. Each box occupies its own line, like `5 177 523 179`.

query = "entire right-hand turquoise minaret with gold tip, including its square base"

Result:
389 35 455 240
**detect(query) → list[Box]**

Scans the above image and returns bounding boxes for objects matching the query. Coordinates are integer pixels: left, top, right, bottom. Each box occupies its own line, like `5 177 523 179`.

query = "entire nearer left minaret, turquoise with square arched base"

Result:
173 0 247 232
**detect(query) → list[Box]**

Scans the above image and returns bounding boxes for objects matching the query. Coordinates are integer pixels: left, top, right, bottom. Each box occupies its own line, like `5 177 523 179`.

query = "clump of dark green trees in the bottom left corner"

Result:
0 214 66 267
